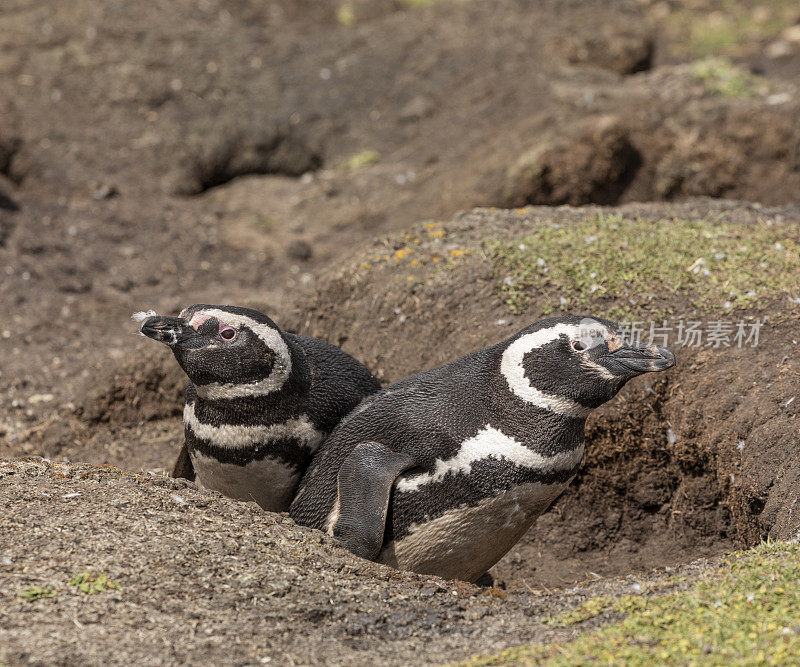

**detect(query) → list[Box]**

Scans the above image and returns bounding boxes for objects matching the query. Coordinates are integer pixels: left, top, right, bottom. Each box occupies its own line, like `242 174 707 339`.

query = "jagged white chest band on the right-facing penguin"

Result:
395 424 583 493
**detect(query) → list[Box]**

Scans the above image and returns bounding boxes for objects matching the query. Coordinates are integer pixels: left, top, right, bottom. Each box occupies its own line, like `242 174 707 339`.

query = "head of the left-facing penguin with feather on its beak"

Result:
139 304 292 400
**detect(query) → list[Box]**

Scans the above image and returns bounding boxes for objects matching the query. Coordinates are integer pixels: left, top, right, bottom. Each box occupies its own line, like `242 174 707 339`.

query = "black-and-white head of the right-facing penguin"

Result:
501 315 675 417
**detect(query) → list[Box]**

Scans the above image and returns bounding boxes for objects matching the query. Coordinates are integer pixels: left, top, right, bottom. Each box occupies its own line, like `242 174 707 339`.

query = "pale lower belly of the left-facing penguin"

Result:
191 451 300 512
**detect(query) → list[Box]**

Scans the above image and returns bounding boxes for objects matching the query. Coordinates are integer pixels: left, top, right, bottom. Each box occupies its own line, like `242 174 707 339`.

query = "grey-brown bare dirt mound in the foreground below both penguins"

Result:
0 460 708 665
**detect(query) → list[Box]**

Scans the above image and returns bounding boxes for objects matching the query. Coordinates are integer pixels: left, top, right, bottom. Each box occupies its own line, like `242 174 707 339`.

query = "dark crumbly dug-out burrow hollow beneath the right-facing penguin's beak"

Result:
492 374 736 588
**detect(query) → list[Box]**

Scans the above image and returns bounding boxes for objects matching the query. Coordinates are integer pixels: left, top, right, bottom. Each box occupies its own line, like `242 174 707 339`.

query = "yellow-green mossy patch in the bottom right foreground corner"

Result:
468 542 800 667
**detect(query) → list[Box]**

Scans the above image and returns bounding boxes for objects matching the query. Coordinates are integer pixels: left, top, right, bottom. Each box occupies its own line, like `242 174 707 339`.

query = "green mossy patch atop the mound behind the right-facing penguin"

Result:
484 214 800 319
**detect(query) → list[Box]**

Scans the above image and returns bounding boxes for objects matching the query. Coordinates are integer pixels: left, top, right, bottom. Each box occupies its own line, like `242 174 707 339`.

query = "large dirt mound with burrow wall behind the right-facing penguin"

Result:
290 201 800 586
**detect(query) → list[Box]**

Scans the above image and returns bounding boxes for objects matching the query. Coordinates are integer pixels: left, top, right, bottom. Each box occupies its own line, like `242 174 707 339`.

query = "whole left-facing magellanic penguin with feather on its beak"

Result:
134 304 380 512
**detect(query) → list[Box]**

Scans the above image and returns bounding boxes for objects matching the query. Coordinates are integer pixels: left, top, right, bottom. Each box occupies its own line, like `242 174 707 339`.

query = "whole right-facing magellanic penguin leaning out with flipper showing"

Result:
289 316 675 581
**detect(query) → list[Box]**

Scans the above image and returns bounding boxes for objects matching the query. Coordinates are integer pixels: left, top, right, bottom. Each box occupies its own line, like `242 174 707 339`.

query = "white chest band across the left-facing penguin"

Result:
183 403 323 452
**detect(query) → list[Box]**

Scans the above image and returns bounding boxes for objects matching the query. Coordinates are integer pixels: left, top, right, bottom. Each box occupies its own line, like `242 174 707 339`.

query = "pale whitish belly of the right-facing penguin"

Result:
378 480 571 581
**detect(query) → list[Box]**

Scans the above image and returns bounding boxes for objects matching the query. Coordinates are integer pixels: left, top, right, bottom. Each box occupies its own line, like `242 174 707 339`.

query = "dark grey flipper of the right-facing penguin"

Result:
333 442 414 560
